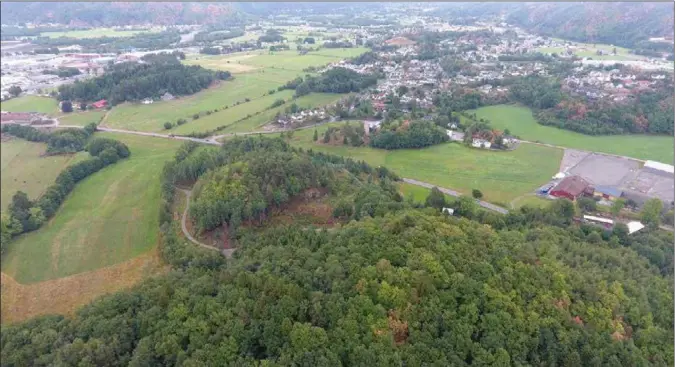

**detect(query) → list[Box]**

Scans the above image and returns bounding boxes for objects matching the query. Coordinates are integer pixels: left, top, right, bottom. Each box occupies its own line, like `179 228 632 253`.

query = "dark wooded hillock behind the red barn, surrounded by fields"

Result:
58 53 230 105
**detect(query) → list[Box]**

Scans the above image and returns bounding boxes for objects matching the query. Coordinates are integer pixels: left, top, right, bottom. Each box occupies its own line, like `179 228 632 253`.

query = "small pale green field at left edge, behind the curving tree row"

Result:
0 139 87 211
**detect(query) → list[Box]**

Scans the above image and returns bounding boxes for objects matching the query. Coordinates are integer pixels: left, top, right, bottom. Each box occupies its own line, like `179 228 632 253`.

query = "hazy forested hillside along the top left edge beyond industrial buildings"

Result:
0 1 245 27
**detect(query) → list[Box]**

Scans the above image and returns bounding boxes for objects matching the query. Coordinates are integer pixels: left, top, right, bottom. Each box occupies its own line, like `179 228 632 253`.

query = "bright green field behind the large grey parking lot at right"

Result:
468 105 673 164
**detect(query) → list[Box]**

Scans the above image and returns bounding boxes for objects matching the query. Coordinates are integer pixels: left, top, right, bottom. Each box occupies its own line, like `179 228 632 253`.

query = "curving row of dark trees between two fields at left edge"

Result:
0 138 131 252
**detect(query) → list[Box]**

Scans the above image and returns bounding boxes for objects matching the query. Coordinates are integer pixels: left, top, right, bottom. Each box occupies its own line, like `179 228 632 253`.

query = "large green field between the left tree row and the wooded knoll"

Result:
2 133 181 284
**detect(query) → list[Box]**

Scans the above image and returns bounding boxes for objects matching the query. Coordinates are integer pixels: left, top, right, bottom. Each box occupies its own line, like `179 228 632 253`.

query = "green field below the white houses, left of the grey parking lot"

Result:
280 123 563 205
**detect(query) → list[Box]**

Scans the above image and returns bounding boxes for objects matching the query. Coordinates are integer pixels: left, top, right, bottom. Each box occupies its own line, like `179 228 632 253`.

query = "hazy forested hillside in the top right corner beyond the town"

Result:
506 2 674 48
